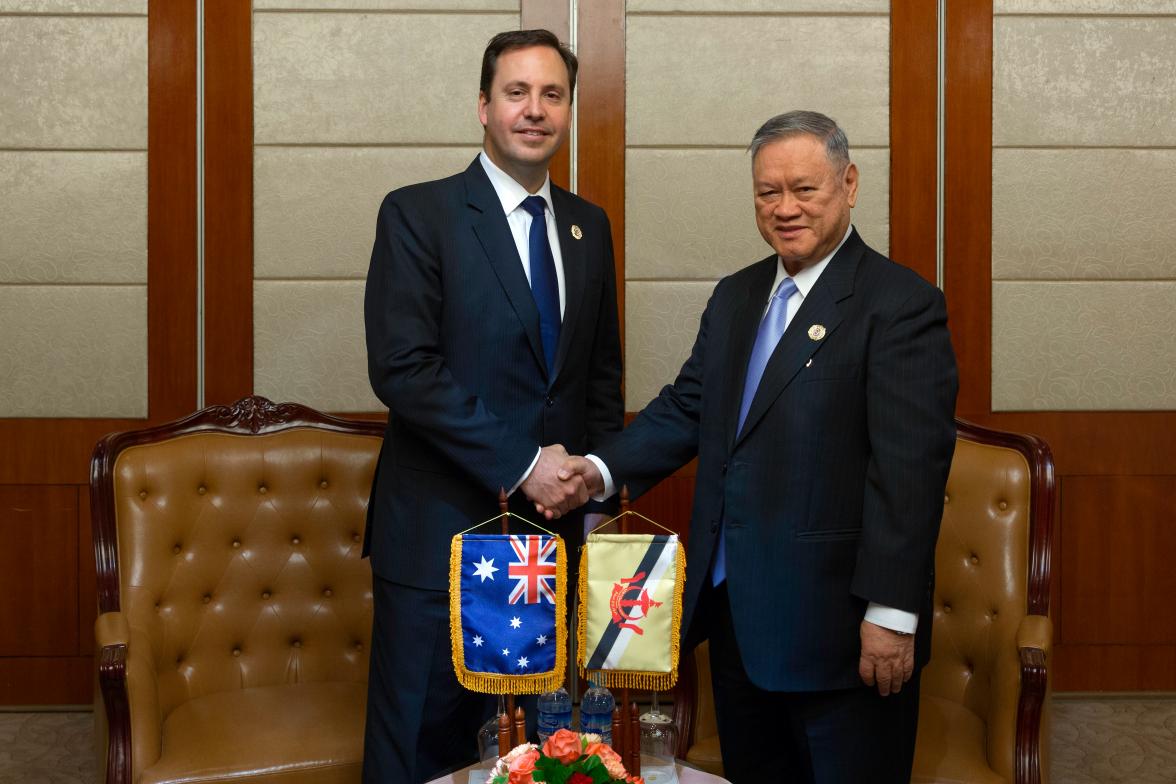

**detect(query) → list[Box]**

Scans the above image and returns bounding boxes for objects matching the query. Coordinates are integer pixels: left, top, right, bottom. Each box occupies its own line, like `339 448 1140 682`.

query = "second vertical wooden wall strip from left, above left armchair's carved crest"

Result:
205 0 253 404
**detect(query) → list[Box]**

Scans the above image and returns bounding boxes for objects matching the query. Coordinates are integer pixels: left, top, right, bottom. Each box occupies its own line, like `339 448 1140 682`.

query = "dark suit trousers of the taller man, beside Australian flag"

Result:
363 575 496 784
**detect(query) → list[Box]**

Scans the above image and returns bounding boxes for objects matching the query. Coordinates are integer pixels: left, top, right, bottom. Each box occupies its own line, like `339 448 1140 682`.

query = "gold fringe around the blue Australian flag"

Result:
449 534 568 695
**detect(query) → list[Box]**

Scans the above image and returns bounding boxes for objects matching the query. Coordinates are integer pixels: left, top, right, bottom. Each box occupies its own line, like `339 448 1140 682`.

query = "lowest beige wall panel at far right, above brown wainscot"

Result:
993 282 1176 411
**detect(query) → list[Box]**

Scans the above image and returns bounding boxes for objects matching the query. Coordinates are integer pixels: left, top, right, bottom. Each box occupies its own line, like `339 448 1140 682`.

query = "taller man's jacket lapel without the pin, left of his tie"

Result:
466 158 547 374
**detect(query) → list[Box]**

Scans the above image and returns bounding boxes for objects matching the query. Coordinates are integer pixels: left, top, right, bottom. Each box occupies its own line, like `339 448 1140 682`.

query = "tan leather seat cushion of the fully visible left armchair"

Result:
140 683 367 784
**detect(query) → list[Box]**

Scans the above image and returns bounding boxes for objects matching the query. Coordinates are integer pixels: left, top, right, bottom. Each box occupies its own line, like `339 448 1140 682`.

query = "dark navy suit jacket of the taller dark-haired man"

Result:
363 159 623 589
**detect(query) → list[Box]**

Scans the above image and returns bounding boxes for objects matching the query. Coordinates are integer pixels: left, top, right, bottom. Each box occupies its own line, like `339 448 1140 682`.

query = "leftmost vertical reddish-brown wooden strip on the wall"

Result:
147 2 196 421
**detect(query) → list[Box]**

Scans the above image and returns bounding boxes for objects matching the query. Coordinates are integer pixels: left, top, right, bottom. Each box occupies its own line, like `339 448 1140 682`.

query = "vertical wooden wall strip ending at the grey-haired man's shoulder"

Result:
890 2 938 283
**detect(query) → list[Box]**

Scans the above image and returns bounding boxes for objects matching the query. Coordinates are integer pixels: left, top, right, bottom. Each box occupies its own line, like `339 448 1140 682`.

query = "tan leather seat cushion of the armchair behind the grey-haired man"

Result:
910 695 1008 784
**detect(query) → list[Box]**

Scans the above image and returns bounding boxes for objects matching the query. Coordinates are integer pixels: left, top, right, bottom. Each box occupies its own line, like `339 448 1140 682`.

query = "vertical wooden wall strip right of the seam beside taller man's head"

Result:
577 0 626 349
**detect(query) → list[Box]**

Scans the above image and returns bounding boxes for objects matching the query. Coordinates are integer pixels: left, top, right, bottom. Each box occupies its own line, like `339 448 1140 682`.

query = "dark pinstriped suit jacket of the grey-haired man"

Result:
596 230 957 691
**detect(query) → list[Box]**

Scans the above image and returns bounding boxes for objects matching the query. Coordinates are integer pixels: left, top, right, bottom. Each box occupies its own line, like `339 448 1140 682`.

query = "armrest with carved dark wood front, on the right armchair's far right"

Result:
1014 615 1054 784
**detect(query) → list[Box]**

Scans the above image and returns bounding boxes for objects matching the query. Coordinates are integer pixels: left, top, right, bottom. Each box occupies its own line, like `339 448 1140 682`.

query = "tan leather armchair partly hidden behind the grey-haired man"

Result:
674 420 1055 784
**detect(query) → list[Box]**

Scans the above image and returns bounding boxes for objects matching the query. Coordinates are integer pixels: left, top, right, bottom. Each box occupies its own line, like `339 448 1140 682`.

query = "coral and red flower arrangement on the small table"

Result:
486 730 644 784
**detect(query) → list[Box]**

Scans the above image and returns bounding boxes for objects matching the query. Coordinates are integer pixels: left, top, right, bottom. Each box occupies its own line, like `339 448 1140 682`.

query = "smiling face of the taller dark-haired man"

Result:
477 46 572 193
